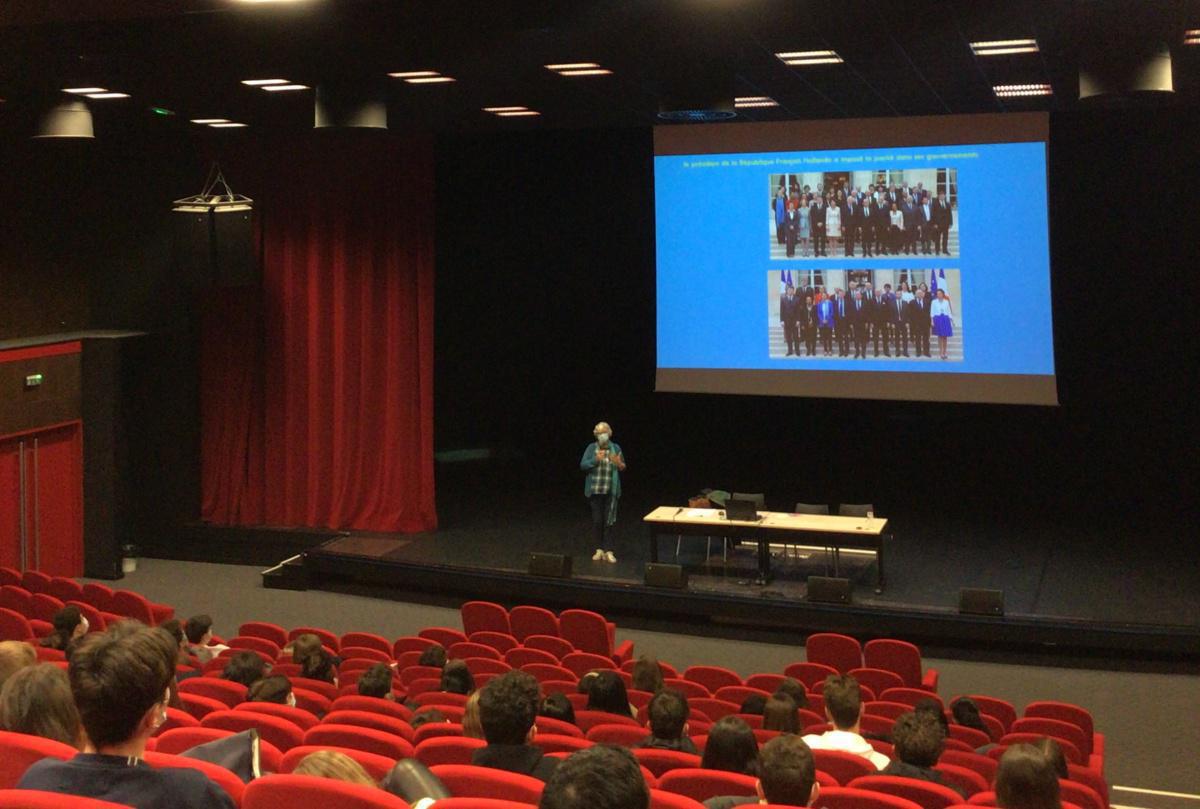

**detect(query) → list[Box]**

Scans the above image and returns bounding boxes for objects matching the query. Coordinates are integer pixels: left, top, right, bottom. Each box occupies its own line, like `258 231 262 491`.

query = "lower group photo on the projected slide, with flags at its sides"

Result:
767 269 964 362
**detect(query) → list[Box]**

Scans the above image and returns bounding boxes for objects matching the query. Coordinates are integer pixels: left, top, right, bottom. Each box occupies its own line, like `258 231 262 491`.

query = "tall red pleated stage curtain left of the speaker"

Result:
202 133 437 532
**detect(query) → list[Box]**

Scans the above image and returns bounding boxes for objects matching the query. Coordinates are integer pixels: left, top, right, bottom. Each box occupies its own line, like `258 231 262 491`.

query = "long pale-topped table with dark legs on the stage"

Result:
642 505 888 593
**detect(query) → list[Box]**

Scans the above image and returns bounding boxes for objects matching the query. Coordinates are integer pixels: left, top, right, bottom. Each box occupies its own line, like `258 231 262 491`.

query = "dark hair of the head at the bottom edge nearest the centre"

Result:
538 744 650 809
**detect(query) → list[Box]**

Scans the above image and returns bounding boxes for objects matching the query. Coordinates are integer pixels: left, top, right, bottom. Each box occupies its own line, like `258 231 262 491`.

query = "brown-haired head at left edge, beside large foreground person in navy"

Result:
0 663 86 750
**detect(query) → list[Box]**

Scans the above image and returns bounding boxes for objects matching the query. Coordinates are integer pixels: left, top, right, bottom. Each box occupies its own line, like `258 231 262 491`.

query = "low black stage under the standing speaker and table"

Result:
246 463 1200 660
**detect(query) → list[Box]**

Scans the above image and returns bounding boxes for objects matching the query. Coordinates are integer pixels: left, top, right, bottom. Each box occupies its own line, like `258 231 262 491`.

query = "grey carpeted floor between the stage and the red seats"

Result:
88 559 1200 792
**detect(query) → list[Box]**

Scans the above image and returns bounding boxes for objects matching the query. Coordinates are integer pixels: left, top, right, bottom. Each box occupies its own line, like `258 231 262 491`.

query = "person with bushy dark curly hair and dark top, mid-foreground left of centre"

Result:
470 670 558 780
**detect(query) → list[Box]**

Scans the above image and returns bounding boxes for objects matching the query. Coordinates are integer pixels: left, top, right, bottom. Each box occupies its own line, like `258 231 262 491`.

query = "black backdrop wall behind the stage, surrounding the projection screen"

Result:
437 110 1196 541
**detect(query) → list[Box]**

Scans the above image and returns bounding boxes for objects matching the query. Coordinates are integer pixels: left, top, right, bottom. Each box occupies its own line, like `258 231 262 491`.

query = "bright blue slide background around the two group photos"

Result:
654 143 1054 374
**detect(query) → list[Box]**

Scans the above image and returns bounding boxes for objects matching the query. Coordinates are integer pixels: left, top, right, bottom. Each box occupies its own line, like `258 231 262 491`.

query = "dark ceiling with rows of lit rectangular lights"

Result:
0 0 1200 131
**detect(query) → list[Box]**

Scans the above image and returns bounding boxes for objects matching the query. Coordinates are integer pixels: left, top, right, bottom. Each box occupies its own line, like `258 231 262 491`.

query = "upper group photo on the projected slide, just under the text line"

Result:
768 168 959 259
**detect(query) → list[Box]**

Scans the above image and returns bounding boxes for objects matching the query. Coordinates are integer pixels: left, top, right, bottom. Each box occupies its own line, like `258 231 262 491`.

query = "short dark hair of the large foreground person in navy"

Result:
67 622 179 749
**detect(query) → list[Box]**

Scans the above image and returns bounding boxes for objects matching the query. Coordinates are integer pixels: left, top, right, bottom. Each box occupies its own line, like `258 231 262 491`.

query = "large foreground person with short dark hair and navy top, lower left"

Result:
18 625 234 809
